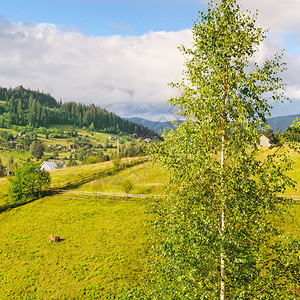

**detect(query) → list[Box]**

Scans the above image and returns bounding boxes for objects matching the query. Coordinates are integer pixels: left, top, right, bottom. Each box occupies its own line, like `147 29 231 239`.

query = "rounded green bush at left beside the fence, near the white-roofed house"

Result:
9 163 51 204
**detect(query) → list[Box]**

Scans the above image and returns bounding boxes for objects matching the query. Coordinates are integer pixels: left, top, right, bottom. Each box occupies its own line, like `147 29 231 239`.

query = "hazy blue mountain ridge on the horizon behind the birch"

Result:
127 114 300 133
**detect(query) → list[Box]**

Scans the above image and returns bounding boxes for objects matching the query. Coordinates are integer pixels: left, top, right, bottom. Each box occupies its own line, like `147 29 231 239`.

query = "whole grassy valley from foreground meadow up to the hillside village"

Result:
0 89 300 299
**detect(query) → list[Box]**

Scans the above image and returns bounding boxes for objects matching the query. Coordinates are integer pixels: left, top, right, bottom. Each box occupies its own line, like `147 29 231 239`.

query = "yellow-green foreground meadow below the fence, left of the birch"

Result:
0 196 148 299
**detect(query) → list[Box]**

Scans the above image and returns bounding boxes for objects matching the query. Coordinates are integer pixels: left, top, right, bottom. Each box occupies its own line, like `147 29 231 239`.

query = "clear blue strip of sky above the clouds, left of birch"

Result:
1 0 206 36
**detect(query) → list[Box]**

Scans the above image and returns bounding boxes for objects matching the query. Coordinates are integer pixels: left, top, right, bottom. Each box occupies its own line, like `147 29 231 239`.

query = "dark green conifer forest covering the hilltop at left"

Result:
0 86 157 137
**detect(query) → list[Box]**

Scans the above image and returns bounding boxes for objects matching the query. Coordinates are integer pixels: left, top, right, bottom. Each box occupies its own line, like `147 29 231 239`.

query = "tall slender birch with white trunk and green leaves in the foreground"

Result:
147 0 299 300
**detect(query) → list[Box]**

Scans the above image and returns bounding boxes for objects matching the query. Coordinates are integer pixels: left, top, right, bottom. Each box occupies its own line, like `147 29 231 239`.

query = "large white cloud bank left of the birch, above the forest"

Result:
0 20 192 116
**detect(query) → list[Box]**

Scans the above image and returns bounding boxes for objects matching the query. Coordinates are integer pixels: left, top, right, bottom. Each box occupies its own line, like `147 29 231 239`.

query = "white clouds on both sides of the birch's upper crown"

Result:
0 0 300 120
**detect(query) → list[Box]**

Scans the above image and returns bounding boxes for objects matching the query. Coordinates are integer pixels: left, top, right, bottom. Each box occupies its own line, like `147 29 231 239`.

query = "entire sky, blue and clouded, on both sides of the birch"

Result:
0 0 300 121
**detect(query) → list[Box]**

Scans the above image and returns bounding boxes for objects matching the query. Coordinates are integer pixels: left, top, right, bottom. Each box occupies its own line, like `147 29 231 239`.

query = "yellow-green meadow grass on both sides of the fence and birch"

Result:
0 150 300 299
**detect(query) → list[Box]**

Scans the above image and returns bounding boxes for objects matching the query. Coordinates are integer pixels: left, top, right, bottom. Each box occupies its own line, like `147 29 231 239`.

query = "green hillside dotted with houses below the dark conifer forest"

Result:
0 126 145 171
